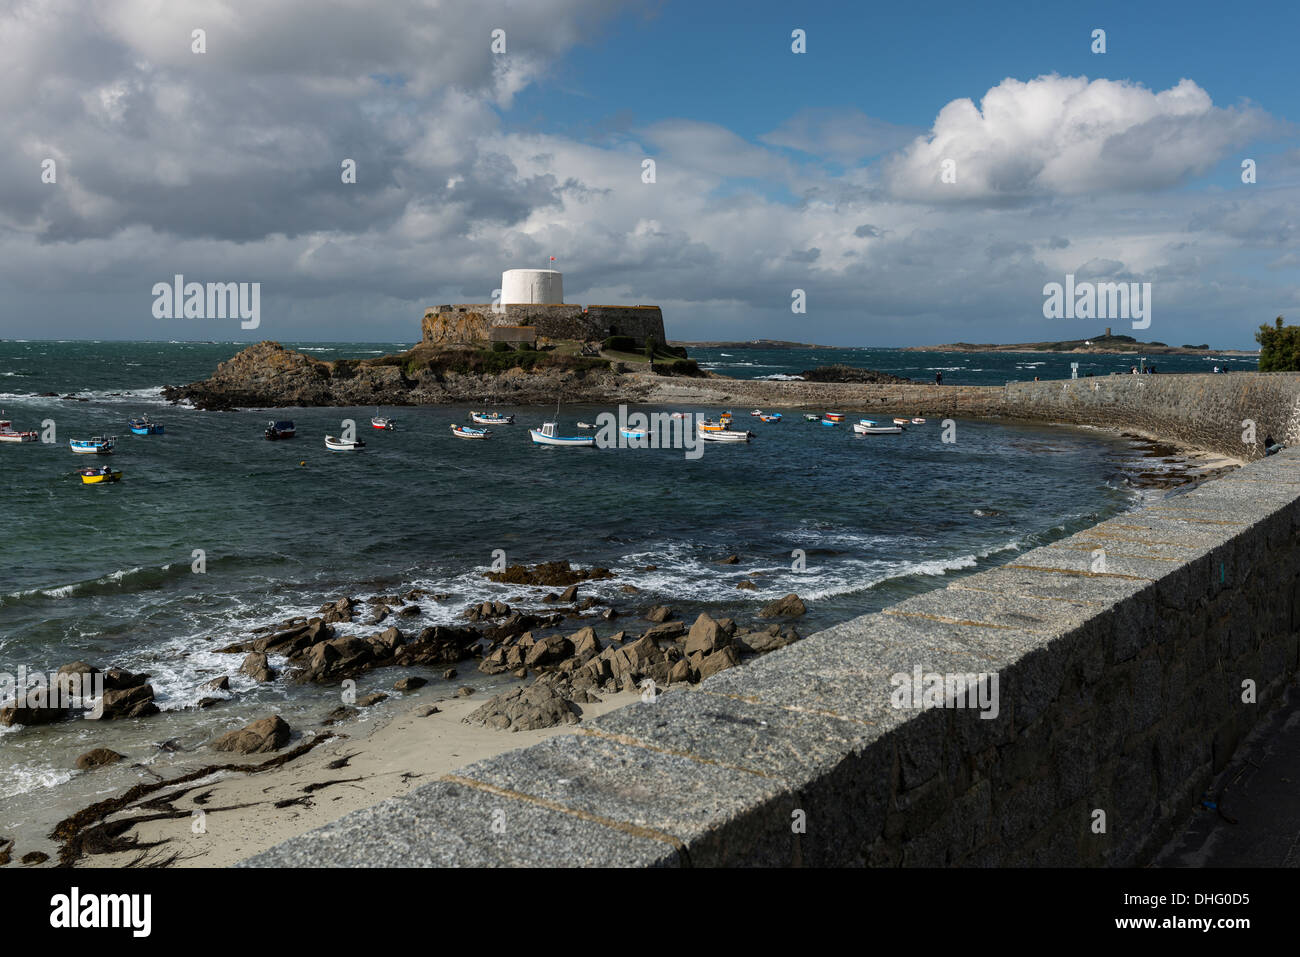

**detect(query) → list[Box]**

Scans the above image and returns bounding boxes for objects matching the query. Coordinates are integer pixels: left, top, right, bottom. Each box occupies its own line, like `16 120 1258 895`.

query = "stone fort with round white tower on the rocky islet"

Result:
421 269 666 346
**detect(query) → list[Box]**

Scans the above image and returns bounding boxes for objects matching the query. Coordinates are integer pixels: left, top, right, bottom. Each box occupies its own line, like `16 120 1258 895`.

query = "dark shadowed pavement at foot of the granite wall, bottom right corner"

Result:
1152 685 1300 867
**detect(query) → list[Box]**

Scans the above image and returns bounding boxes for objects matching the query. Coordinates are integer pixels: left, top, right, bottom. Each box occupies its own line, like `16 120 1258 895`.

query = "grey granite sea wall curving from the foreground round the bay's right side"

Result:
246 374 1300 866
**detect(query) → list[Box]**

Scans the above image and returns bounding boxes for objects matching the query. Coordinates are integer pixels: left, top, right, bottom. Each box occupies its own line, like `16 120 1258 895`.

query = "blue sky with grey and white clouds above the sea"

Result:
0 0 1300 348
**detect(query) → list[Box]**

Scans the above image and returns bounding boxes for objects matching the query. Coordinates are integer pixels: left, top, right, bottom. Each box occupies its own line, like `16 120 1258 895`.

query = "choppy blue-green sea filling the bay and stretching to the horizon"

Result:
0 341 1255 835
